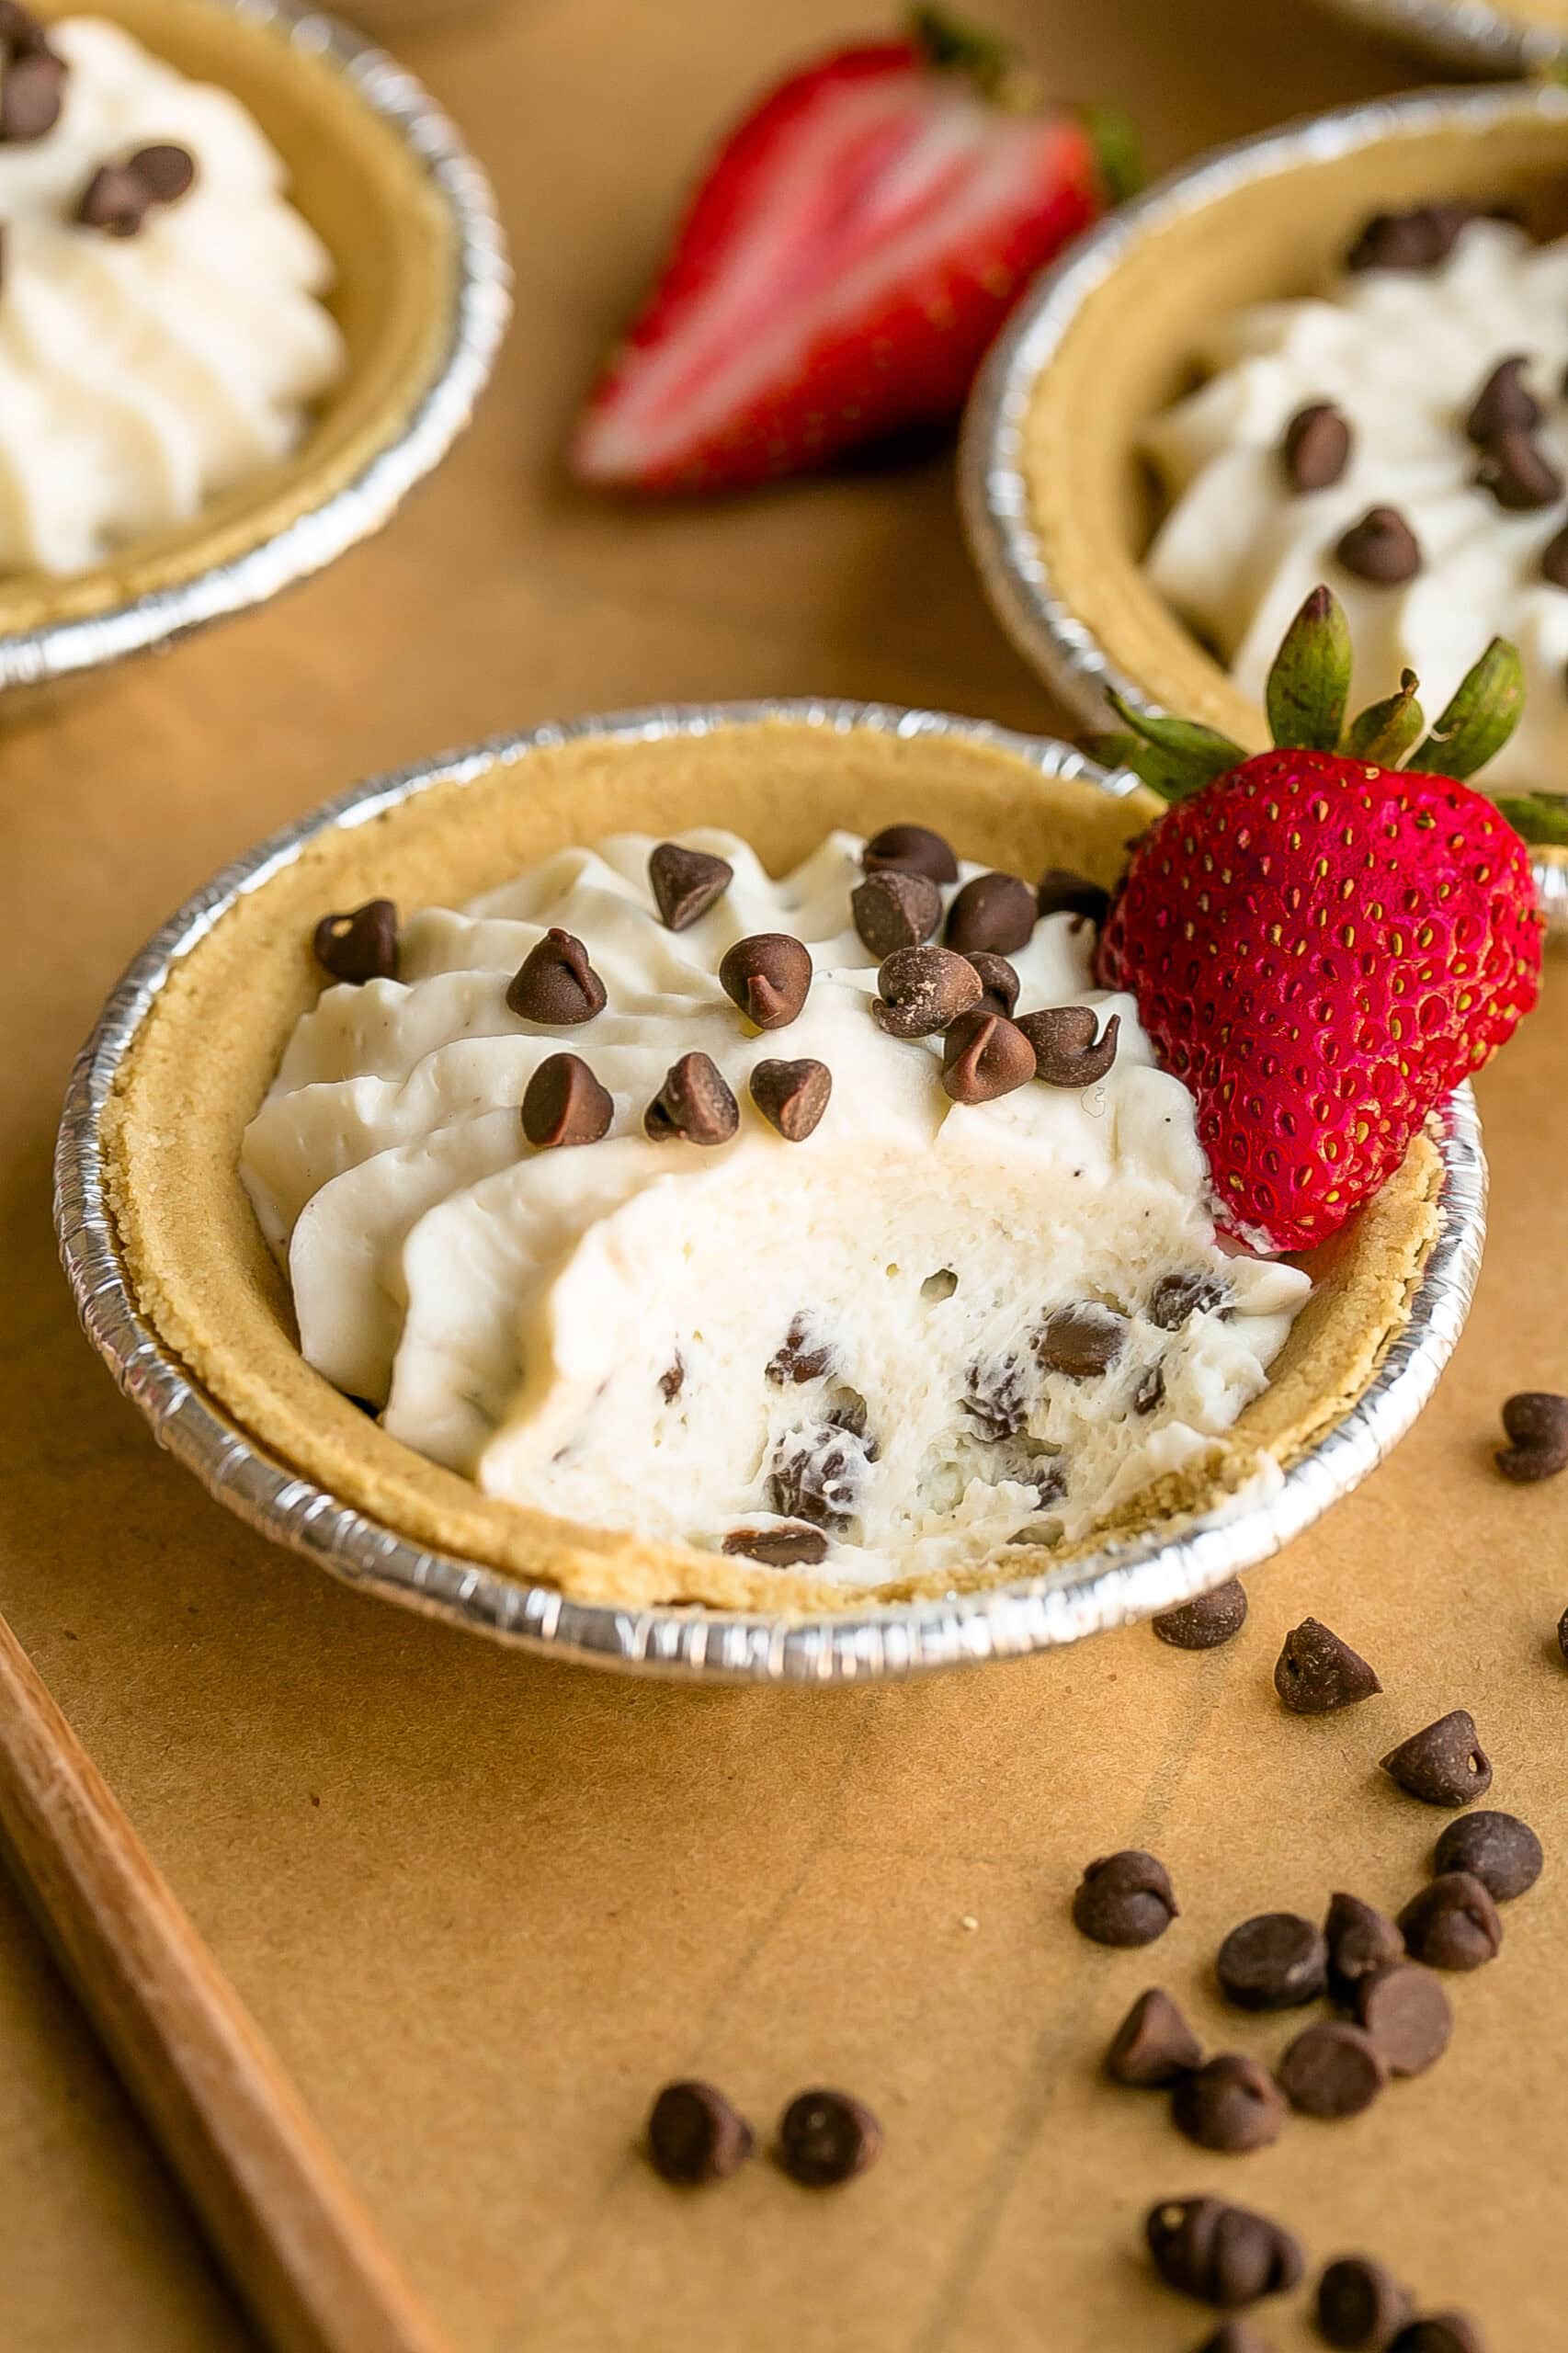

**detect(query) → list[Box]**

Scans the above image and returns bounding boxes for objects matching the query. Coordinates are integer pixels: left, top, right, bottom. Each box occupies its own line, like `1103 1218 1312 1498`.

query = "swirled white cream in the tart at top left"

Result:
0 9 344 574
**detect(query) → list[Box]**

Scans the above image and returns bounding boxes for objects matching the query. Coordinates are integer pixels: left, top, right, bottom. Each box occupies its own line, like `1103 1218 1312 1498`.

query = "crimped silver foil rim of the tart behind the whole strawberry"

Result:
959 74 1568 929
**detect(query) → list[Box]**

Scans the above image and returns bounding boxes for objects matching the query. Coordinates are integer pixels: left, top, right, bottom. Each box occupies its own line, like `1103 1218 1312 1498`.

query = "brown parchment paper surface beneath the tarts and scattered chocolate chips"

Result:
0 0 1568 2353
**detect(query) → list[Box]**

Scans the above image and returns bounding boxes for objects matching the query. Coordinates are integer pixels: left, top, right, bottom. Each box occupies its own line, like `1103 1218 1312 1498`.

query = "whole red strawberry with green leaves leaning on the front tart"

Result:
1087 588 1568 1249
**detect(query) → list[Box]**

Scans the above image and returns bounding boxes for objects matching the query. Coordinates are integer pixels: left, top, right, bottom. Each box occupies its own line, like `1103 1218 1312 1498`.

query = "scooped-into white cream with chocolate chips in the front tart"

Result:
243 831 1309 1584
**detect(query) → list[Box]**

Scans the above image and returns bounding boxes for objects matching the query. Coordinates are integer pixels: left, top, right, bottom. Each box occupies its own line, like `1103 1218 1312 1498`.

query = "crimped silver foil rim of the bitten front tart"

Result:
54 701 1485 1682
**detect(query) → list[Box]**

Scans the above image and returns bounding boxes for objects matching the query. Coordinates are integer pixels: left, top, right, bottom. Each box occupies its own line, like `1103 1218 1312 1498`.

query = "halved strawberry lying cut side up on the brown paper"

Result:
572 7 1135 492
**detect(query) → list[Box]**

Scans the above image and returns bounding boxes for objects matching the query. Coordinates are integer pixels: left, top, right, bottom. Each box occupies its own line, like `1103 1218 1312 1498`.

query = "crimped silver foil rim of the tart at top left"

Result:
0 0 511 694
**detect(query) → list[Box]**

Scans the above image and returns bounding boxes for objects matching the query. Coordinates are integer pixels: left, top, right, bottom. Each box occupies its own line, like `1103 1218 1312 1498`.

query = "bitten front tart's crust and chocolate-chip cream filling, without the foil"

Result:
101 715 1441 1614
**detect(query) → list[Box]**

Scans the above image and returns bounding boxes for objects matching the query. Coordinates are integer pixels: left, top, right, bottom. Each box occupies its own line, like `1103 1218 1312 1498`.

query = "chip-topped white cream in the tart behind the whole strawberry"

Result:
1144 207 1568 786
